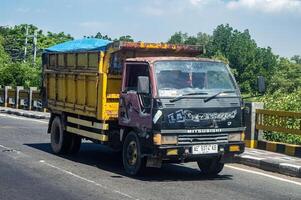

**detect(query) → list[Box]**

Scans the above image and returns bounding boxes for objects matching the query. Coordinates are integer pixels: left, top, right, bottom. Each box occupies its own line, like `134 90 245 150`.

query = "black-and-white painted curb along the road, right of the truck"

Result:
238 155 301 178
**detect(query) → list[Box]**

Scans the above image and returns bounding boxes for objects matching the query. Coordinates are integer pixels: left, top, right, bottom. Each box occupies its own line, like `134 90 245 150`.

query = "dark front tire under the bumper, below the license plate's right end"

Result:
197 158 224 176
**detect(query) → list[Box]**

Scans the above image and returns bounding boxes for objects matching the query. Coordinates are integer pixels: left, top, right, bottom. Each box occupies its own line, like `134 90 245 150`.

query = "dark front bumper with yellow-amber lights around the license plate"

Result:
154 142 245 163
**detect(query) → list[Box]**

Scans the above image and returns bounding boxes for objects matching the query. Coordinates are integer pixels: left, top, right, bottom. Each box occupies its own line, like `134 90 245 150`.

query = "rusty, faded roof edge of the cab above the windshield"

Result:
126 56 222 63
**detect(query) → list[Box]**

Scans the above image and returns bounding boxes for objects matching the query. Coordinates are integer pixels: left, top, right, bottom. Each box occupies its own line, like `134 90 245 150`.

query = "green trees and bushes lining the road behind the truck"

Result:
0 24 301 144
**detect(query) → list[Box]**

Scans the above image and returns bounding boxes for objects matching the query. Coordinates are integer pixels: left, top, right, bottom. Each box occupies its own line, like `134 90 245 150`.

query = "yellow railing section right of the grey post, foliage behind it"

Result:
255 109 301 135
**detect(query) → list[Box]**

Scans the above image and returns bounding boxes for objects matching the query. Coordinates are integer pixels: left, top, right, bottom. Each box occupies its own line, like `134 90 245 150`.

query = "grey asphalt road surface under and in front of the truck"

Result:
0 114 301 200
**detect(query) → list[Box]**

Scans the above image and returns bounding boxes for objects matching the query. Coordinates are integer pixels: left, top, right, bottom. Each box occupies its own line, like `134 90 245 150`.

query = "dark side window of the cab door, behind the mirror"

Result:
124 64 149 91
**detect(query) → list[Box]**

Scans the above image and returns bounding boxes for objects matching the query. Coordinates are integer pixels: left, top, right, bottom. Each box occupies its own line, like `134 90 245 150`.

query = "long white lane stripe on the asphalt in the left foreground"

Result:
40 160 139 200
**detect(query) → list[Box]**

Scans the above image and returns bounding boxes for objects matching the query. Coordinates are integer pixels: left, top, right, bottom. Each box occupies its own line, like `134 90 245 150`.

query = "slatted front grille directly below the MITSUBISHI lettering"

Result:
178 134 228 145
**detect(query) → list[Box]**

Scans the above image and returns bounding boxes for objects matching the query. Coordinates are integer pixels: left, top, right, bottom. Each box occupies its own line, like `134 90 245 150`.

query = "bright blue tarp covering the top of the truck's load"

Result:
45 38 112 52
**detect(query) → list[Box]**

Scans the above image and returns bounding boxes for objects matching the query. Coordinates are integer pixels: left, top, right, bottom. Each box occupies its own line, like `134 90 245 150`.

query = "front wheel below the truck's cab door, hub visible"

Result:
122 132 146 175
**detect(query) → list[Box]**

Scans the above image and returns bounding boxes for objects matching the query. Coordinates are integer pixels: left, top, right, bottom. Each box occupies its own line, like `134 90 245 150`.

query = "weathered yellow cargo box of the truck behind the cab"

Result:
44 52 121 120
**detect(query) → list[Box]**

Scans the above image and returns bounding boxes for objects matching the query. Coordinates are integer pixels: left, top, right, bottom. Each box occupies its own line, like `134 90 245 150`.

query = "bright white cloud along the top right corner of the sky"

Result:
227 0 301 13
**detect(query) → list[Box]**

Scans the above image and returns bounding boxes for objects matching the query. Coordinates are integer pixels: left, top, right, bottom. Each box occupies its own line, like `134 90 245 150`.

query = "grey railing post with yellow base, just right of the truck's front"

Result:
244 102 264 148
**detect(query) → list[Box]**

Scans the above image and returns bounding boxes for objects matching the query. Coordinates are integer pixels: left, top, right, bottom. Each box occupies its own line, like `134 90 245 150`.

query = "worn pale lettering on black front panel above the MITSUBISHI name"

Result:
168 110 237 123
